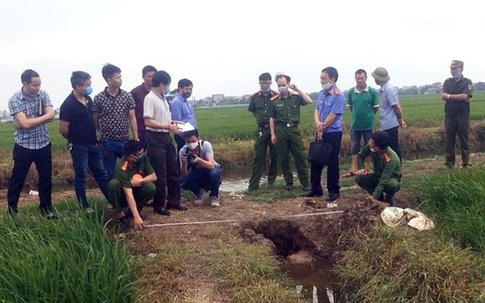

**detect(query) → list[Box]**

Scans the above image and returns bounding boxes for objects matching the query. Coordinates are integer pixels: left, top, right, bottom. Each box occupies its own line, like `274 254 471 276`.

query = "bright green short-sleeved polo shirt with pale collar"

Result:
347 86 379 130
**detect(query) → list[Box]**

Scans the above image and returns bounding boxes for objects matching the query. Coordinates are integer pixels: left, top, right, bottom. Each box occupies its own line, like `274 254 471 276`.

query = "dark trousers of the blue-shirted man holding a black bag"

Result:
310 132 342 194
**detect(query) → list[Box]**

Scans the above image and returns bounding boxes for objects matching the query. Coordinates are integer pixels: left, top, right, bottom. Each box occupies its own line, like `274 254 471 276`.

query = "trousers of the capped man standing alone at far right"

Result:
445 115 470 167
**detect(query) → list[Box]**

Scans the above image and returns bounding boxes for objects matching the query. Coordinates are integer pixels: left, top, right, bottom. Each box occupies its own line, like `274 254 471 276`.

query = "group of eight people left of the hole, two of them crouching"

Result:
7 64 221 229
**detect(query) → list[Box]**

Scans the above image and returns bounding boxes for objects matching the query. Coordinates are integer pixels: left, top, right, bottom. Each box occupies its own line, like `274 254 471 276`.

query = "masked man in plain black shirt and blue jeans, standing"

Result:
59 71 109 213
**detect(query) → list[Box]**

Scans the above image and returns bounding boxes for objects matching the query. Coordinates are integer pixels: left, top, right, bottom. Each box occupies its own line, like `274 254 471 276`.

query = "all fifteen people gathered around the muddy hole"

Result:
7 60 473 229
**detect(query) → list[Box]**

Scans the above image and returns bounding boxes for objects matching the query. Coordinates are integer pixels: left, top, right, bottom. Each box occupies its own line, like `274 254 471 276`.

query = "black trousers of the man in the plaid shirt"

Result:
7 143 52 212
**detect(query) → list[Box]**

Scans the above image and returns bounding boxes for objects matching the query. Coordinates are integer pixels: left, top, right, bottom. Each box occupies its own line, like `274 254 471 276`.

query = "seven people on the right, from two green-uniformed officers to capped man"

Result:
248 60 473 207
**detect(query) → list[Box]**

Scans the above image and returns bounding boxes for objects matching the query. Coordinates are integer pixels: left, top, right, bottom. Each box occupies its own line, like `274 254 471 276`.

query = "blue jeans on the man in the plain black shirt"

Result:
70 144 109 208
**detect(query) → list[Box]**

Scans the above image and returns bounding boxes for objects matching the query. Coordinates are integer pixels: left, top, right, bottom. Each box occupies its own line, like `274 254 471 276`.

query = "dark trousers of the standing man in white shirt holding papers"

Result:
146 131 180 209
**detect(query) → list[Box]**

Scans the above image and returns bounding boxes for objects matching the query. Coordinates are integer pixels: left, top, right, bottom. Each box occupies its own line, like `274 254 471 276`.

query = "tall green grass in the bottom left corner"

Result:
0 201 136 303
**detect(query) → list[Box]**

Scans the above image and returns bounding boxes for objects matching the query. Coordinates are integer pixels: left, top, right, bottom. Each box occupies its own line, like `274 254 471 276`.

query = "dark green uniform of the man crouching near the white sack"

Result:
358 144 402 199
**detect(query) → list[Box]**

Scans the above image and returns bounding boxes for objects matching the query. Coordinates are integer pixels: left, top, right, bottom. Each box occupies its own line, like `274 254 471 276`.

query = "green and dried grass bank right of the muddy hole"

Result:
338 166 485 303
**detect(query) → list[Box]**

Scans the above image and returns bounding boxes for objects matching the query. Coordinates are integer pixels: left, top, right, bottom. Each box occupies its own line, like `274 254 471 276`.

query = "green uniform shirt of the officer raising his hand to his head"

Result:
269 93 306 123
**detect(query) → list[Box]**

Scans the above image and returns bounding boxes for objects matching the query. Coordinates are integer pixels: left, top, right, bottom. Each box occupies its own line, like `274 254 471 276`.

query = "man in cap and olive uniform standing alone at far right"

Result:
441 60 473 168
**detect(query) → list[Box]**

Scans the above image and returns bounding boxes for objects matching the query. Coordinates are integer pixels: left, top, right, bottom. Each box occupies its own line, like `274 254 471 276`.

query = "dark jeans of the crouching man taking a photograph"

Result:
181 164 222 197
